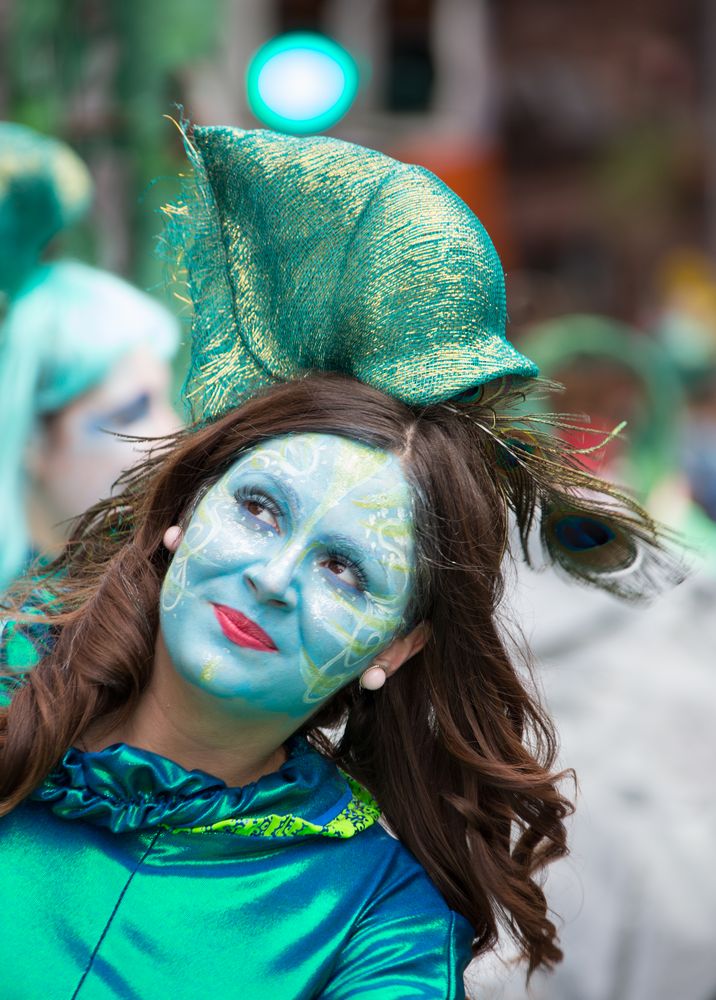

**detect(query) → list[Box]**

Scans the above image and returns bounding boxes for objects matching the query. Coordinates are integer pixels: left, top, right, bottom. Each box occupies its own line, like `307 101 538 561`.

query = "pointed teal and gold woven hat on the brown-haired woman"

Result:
165 127 537 416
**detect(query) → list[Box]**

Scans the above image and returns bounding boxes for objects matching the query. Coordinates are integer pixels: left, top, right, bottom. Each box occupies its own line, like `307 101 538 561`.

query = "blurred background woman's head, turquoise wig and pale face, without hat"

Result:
0 261 179 586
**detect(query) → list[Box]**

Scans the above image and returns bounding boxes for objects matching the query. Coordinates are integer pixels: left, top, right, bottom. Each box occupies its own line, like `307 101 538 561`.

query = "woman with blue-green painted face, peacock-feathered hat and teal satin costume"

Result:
0 128 676 1000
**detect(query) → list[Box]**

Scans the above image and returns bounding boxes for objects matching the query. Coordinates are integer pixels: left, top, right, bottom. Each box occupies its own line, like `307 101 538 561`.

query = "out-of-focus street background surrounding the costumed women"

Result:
0 0 716 1000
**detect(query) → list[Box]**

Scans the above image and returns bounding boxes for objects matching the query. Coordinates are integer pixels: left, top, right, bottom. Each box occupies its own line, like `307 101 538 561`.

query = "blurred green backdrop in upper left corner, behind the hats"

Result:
0 0 226 288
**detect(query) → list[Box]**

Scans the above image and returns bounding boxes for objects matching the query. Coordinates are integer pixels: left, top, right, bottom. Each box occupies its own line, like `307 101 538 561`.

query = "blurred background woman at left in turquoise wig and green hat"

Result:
0 123 179 590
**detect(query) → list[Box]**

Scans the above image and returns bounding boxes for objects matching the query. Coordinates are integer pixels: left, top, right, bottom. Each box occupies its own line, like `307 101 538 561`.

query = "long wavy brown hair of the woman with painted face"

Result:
0 375 570 971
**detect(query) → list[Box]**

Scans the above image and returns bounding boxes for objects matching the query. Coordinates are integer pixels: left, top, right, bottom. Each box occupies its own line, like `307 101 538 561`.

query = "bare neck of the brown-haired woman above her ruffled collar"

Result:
80 635 288 787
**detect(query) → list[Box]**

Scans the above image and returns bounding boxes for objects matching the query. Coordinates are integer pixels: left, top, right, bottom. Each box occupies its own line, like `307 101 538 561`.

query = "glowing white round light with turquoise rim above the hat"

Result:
246 31 359 135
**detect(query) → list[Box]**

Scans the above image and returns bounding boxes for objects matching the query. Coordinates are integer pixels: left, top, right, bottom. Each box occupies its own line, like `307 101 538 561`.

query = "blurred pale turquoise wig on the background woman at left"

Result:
0 261 179 588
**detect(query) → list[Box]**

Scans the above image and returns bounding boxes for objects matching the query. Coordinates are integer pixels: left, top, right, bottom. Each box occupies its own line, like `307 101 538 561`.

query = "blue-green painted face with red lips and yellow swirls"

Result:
160 434 414 720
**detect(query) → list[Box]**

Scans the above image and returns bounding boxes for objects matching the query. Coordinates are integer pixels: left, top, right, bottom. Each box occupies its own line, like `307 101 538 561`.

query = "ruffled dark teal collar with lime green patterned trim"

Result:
32 737 379 839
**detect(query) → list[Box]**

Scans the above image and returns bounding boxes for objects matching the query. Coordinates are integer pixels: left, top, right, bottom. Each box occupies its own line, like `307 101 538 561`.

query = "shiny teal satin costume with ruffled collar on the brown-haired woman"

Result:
0 684 472 1000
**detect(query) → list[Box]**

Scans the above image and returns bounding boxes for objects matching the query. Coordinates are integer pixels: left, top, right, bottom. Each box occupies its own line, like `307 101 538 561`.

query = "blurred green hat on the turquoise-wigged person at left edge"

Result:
0 122 92 298
